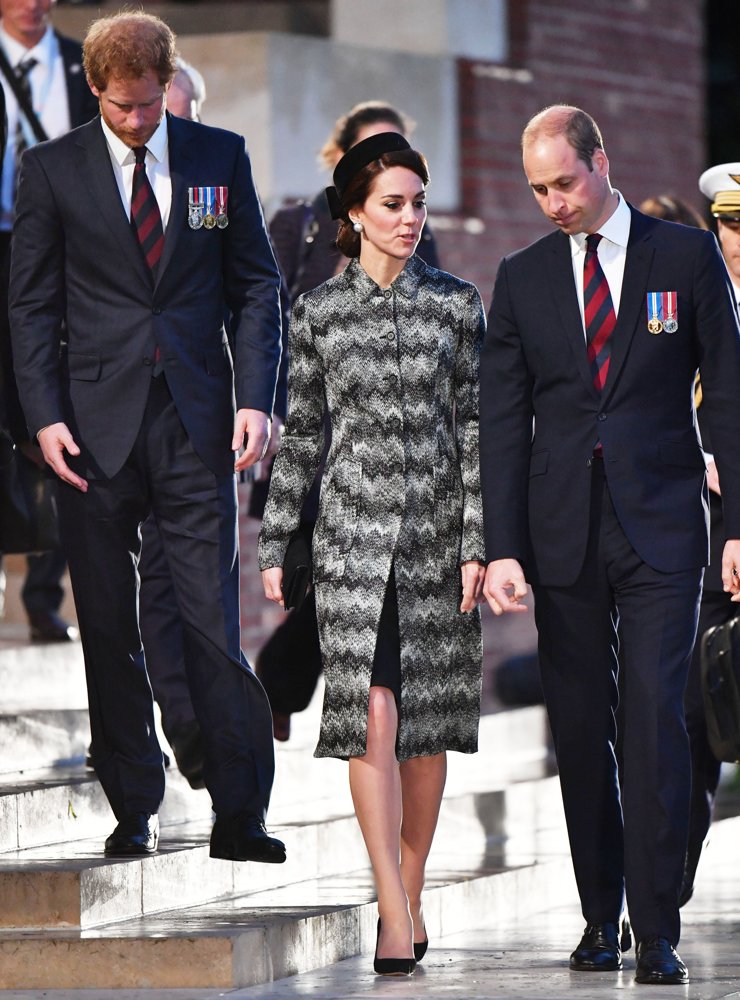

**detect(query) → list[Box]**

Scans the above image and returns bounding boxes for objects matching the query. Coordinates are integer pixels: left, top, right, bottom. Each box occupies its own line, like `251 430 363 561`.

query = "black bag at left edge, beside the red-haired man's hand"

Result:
0 431 59 554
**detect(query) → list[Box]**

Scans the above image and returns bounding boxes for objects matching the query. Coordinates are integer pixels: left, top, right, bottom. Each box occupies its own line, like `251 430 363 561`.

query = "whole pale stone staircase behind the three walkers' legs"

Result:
0 624 572 996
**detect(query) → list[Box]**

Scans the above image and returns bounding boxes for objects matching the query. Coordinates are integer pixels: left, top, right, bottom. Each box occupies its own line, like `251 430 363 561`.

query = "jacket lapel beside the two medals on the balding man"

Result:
603 208 655 399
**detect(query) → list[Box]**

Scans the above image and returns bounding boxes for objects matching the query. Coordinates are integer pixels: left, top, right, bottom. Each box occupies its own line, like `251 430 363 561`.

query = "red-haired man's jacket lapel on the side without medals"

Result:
76 119 152 287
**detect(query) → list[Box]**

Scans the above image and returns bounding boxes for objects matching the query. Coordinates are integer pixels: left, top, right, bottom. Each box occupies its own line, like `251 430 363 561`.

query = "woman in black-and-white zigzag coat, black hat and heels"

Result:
259 132 485 974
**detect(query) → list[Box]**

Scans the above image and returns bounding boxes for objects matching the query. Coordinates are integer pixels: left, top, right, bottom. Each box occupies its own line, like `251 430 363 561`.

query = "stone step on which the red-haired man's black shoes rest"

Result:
0 779 559 929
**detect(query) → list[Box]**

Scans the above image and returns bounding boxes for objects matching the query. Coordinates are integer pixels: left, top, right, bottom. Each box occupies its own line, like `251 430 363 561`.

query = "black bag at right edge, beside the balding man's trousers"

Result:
701 616 740 763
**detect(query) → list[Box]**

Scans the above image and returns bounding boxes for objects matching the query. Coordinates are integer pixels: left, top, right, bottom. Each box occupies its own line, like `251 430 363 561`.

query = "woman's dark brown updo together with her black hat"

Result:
326 132 429 257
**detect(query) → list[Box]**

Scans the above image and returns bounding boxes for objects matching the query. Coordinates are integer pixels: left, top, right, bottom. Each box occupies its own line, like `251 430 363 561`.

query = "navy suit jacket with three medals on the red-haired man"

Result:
10 115 280 477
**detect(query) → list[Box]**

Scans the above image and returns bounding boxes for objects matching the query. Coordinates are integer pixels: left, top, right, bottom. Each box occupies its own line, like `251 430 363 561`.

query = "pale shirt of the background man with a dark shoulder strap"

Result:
0 23 72 230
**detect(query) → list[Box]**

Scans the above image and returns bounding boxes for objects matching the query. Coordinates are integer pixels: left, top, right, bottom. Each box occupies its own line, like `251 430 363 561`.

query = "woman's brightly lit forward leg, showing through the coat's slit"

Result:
349 686 413 958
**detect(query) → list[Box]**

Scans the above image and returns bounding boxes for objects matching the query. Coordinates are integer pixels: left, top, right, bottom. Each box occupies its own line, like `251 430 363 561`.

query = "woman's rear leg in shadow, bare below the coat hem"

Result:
401 753 447 943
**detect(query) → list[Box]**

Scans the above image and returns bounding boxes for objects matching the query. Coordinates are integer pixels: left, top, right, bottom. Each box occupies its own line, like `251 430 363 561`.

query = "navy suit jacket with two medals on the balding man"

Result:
480 209 740 586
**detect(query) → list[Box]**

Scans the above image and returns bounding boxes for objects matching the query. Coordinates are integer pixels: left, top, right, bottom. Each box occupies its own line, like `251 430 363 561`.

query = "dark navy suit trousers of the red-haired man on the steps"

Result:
60 377 274 818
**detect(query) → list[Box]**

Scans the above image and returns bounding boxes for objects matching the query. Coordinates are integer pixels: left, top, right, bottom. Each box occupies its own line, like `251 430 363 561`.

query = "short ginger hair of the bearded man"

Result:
82 11 177 92
